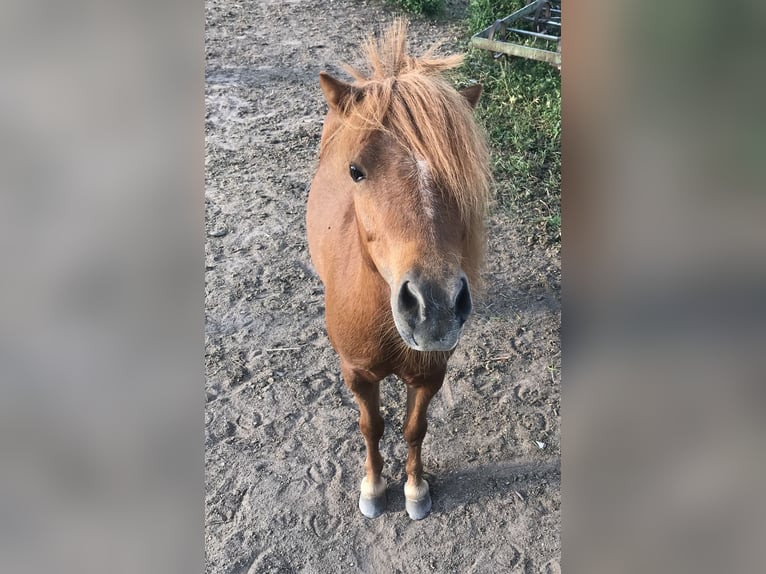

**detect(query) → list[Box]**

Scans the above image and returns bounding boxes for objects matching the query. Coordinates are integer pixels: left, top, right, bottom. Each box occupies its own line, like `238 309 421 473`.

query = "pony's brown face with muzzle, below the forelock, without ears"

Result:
348 132 471 351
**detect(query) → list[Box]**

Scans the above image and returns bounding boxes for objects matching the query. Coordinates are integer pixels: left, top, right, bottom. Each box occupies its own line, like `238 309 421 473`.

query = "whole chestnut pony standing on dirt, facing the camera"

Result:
307 21 489 519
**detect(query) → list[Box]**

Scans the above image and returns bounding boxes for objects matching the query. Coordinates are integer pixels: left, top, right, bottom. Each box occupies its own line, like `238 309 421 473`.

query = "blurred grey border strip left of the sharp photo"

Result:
0 0 204 574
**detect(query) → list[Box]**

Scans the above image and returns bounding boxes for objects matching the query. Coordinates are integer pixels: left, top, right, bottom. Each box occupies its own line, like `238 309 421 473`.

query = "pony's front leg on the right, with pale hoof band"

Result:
404 372 444 520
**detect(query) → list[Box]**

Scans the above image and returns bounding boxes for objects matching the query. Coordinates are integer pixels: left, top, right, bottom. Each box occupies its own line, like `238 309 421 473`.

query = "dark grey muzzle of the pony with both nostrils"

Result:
391 273 473 351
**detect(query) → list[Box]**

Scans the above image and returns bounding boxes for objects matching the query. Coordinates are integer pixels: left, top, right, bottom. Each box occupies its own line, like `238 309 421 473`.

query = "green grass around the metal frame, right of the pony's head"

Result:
455 0 561 243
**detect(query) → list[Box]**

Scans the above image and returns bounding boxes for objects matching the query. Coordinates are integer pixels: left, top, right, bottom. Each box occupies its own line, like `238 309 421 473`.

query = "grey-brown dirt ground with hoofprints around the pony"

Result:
205 0 561 574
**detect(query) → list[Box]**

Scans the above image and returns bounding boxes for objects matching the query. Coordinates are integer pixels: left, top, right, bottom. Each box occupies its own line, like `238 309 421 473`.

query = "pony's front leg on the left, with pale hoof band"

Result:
341 363 386 518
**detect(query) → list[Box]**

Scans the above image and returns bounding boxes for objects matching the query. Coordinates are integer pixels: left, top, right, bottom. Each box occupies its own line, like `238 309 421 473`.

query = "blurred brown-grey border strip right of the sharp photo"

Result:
562 1 766 574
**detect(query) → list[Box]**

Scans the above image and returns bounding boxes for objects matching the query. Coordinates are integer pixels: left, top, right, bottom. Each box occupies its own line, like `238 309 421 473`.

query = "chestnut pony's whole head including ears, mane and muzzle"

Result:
320 22 489 351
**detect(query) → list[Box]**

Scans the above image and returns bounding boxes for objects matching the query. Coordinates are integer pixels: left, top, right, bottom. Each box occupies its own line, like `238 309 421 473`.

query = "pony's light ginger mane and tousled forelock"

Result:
323 20 490 286
